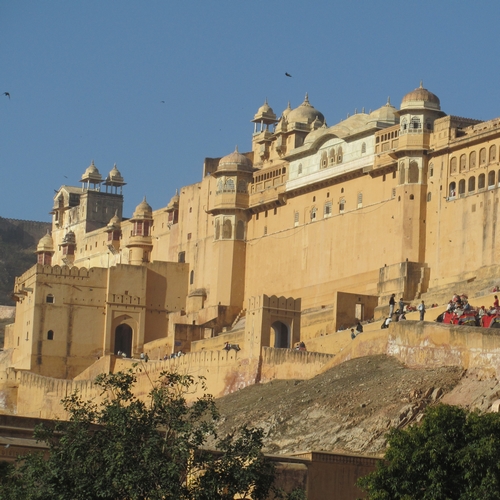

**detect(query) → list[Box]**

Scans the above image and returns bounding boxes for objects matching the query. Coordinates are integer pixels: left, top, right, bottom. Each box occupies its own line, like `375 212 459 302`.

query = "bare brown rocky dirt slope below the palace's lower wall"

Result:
214 355 464 455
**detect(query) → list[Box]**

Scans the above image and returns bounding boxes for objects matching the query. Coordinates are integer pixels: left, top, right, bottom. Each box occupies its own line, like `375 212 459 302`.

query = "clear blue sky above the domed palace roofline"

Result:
0 0 500 221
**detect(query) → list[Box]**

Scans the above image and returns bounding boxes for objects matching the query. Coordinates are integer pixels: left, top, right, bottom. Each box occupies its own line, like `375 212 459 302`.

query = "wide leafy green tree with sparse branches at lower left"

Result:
0 371 286 500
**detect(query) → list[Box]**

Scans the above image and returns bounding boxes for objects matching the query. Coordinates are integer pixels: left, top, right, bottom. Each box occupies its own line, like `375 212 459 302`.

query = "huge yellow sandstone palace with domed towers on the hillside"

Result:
0 85 500 410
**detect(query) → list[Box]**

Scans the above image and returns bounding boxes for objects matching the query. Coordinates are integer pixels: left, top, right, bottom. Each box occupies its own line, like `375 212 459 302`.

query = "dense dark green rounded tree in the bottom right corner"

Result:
358 405 500 500
